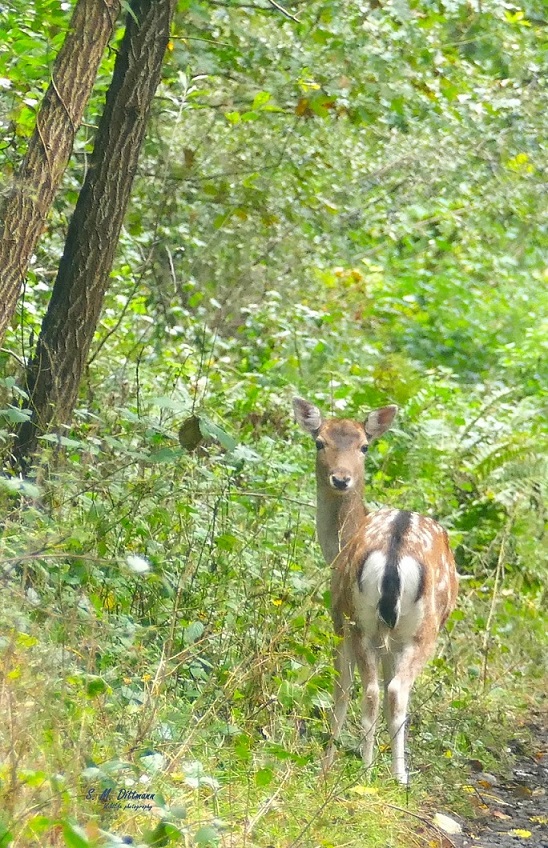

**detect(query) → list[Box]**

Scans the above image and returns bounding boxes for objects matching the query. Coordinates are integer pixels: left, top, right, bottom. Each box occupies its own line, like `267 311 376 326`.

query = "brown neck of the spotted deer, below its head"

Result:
316 487 367 565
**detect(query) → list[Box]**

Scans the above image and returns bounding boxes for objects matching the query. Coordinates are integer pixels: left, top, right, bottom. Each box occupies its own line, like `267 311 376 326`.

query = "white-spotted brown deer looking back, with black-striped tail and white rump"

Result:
293 397 458 785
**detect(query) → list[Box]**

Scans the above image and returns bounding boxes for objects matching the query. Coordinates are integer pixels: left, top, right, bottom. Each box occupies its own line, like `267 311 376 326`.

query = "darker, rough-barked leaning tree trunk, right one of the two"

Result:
14 0 176 465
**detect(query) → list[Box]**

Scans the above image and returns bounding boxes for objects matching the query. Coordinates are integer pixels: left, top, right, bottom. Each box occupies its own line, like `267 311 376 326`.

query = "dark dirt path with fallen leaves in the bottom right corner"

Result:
451 715 548 848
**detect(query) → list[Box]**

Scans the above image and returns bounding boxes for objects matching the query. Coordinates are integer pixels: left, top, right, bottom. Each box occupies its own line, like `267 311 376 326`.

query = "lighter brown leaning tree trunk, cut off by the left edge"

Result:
0 0 120 341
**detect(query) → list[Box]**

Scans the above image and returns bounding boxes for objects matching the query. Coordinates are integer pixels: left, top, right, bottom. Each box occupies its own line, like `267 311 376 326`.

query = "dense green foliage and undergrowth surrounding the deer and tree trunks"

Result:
0 0 548 846
